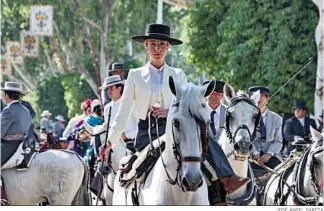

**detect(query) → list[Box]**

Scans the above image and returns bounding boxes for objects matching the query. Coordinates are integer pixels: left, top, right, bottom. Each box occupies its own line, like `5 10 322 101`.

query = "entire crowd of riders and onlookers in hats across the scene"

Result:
1 24 323 203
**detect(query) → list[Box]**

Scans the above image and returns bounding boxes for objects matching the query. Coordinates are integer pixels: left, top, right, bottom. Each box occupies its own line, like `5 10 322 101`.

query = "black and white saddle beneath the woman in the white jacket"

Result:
119 135 165 186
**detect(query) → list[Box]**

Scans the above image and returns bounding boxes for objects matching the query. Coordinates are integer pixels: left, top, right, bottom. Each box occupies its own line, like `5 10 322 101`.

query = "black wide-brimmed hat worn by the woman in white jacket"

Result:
132 23 182 45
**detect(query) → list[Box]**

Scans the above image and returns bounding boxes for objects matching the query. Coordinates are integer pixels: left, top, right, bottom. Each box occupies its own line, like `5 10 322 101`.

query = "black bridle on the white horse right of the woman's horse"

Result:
223 96 261 144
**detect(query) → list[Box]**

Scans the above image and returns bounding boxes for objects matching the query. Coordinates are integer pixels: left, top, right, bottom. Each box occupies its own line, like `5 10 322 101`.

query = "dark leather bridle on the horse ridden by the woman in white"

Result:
156 101 209 191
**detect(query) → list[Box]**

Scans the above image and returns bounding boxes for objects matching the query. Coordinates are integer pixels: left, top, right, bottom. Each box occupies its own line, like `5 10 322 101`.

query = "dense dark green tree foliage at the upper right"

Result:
188 0 318 113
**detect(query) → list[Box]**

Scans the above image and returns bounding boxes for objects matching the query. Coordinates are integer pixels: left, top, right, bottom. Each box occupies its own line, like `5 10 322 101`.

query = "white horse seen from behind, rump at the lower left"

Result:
1 150 91 205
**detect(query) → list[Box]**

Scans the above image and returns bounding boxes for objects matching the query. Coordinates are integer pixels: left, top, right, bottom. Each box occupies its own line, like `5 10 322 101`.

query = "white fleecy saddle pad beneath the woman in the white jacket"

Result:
119 135 165 181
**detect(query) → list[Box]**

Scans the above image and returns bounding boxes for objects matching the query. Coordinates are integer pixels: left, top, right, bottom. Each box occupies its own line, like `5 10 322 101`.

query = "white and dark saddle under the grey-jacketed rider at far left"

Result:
1 139 37 171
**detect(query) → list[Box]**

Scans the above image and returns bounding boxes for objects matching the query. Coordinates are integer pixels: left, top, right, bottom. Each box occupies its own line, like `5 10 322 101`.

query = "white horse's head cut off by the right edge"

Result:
307 126 324 197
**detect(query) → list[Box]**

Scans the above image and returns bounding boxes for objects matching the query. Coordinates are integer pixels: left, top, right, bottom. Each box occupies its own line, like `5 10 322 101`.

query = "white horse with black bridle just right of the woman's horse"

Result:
219 84 261 206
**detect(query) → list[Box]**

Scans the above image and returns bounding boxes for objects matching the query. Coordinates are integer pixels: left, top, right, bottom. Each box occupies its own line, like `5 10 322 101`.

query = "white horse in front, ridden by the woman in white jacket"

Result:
113 77 215 205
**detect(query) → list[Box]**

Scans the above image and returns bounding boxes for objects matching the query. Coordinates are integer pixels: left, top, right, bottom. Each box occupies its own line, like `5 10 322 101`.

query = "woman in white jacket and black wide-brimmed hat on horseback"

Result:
101 23 249 198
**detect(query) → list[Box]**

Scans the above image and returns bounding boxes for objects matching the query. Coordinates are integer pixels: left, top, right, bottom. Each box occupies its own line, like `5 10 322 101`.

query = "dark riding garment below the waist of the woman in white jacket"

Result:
135 116 167 152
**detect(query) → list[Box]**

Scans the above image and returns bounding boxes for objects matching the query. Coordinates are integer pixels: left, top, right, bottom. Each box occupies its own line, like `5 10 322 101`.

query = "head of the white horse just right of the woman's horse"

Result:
222 84 261 160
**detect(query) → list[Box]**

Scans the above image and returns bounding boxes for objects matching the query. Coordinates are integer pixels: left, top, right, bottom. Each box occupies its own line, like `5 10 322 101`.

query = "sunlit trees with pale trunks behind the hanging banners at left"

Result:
1 0 191 117
